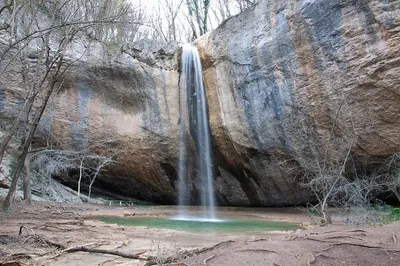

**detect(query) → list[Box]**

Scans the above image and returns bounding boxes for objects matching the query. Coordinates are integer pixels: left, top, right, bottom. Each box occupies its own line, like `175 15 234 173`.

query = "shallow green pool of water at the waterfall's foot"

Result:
97 216 299 232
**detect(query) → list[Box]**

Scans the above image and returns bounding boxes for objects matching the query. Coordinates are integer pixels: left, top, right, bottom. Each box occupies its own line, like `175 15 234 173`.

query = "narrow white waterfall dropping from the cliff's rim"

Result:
178 44 216 221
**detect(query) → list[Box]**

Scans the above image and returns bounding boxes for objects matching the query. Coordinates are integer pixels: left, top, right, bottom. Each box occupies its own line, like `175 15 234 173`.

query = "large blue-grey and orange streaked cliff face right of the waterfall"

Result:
197 0 400 205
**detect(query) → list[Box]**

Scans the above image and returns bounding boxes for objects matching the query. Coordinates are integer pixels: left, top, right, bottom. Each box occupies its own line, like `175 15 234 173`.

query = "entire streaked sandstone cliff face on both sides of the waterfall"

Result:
0 0 400 206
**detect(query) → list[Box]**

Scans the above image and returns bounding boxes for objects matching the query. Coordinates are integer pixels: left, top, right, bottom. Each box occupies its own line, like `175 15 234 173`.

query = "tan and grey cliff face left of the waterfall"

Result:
52 42 183 203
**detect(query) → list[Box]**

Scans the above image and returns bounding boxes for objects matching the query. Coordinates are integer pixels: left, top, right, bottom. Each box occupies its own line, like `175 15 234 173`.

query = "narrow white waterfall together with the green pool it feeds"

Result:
98 44 299 231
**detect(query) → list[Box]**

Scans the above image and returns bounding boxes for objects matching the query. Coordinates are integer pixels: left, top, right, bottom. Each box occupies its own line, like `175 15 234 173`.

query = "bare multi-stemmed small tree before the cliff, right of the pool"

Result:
293 97 360 223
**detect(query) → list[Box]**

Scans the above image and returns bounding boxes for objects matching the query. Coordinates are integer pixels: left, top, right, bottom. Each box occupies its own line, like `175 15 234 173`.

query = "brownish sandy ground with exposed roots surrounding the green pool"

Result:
0 203 400 266
